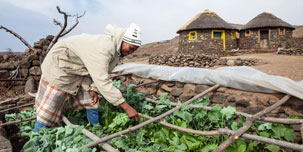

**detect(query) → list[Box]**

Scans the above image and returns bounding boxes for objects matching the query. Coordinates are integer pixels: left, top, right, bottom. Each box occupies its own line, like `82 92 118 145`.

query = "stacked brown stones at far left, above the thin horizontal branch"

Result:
0 35 53 81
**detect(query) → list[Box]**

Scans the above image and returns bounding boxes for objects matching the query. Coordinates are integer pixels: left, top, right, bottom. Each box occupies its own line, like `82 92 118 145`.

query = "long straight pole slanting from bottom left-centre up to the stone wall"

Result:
80 84 220 150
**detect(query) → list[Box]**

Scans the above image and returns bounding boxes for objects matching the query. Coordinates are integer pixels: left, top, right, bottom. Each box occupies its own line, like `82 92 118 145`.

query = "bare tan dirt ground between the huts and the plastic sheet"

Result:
124 53 303 81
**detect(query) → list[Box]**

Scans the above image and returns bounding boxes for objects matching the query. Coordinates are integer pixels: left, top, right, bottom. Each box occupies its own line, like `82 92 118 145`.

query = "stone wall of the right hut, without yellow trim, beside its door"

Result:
239 28 294 49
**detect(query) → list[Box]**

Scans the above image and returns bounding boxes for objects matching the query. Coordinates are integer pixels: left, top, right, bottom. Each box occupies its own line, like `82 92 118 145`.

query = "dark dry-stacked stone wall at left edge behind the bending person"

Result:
0 35 53 96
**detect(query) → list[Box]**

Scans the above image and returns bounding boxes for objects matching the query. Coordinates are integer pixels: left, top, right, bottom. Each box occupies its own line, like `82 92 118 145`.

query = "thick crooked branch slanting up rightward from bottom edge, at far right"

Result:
213 95 291 152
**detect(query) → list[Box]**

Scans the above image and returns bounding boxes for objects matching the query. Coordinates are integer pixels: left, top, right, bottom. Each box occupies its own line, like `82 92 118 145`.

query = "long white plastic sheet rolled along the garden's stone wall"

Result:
114 63 303 99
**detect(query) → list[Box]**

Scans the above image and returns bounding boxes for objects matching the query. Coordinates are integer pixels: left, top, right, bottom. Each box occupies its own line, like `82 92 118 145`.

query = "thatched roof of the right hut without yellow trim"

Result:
241 12 295 30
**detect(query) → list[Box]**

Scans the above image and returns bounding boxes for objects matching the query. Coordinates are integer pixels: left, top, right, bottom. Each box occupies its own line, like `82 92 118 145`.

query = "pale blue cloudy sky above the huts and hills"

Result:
0 0 303 52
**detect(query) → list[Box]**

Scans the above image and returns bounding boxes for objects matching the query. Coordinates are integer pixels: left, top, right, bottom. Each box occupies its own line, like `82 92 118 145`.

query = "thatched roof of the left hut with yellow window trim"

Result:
177 10 236 33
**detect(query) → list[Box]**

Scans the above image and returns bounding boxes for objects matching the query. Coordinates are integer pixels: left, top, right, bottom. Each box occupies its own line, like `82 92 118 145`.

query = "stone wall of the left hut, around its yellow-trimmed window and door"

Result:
179 30 237 56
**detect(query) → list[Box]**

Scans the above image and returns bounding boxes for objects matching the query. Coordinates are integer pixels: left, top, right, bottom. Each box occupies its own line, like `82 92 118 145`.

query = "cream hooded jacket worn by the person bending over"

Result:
41 25 126 106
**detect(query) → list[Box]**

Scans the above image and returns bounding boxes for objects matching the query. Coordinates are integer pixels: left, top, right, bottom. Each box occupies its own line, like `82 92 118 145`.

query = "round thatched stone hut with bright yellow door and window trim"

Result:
177 10 237 54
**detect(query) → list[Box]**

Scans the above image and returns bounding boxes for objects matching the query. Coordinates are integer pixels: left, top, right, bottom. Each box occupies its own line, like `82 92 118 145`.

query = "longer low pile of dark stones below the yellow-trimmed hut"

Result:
149 54 219 68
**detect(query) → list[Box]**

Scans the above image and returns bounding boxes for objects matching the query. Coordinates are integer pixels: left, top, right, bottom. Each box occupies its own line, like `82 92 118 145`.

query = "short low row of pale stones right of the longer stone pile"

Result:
218 58 260 66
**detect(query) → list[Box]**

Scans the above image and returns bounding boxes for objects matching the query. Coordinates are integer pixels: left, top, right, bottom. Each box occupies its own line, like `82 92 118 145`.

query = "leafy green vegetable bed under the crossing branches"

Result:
0 81 303 152
